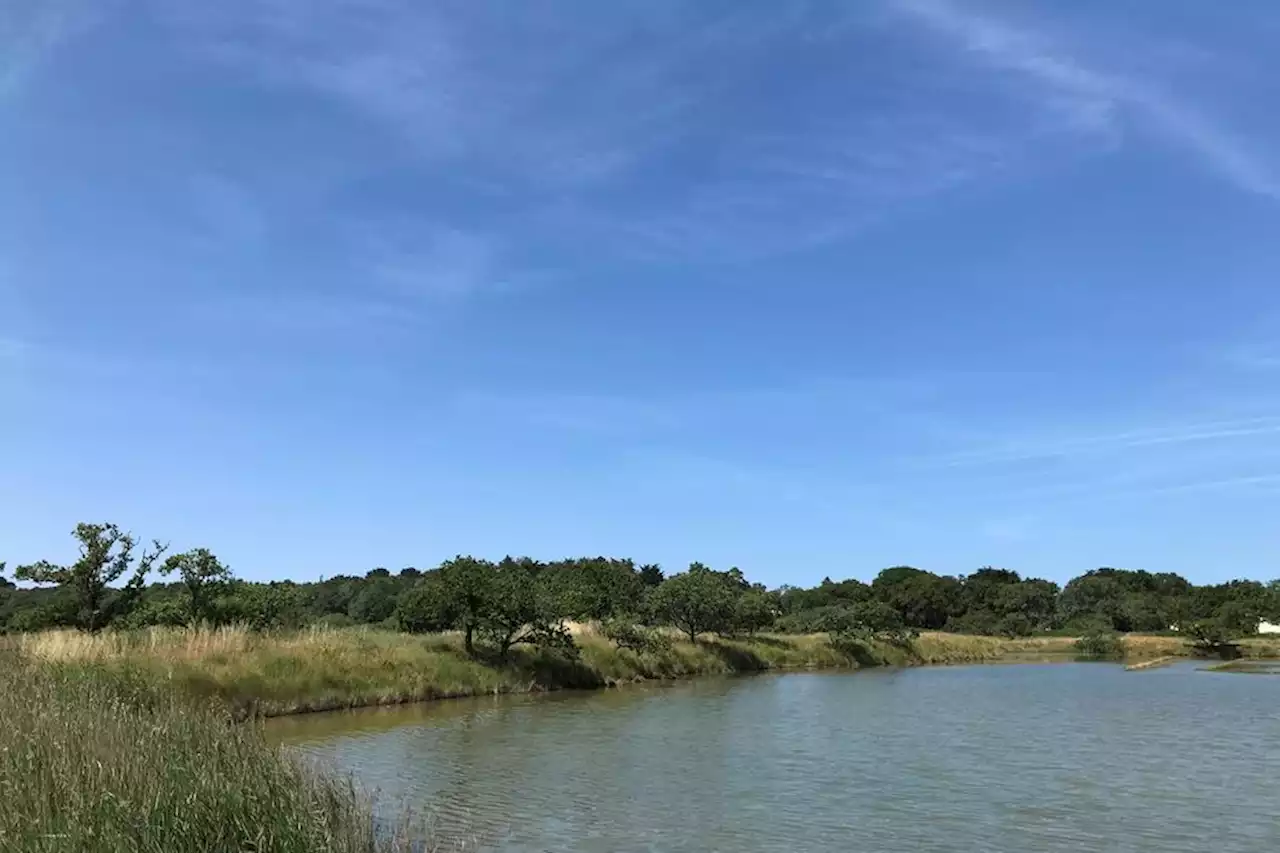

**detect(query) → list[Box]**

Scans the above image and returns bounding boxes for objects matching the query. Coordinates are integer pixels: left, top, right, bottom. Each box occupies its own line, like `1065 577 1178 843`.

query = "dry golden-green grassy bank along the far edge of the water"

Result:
15 628 1280 717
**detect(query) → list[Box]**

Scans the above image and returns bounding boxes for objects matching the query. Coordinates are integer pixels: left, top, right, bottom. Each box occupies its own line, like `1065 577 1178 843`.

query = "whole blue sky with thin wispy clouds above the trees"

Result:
0 0 1280 584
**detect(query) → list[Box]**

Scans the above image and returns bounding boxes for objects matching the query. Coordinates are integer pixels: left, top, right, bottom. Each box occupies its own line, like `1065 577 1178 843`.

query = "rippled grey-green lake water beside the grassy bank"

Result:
269 663 1280 853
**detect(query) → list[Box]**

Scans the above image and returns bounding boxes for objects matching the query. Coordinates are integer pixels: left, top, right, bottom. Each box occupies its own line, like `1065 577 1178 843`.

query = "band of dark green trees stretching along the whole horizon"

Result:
0 524 1280 656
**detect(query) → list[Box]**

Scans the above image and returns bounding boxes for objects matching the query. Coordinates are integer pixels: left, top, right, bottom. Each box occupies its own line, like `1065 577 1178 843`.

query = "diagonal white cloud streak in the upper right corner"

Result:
895 0 1280 199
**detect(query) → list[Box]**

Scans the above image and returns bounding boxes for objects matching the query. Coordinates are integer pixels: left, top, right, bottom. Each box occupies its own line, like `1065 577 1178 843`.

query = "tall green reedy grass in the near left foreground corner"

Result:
0 653 424 853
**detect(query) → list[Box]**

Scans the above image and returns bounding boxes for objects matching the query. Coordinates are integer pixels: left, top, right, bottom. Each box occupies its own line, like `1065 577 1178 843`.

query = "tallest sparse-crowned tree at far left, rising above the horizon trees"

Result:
14 523 166 631
